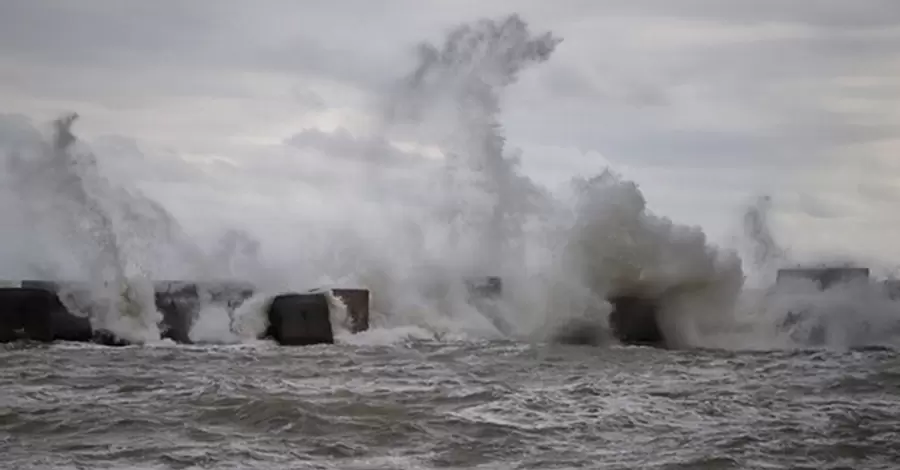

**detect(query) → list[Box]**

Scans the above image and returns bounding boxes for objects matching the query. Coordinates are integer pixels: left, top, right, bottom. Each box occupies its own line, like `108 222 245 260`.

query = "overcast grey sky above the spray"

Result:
0 0 900 276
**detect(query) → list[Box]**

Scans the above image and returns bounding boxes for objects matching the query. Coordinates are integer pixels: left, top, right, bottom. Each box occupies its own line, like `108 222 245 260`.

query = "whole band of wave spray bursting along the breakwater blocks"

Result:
0 15 900 348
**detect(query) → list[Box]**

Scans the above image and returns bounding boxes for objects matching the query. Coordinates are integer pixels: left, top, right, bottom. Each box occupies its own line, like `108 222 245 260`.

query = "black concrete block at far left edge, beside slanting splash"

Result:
0 287 93 342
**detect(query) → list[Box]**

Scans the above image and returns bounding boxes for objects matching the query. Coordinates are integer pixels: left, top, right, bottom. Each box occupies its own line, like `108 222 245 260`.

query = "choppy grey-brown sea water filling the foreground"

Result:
0 341 900 469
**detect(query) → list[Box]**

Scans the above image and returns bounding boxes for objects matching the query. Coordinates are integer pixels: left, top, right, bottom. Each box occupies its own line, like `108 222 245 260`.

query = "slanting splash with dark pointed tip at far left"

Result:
10 114 162 343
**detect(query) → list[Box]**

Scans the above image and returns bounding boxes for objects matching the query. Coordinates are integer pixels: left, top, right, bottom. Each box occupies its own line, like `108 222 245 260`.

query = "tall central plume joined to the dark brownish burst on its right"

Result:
344 15 742 345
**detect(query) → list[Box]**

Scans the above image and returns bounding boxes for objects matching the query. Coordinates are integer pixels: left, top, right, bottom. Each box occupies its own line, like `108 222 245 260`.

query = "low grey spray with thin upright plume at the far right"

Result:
724 196 900 349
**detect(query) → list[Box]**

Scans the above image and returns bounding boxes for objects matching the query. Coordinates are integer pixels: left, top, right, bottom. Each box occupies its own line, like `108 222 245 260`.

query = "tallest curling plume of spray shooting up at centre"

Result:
389 15 561 275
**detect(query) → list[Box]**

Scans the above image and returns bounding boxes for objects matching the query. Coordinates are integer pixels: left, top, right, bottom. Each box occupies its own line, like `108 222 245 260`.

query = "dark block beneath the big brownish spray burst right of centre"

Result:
609 295 666 347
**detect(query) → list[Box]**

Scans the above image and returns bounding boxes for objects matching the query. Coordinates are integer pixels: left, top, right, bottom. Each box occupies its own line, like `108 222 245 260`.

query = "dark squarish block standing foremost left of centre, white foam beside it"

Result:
268 293 334 346
